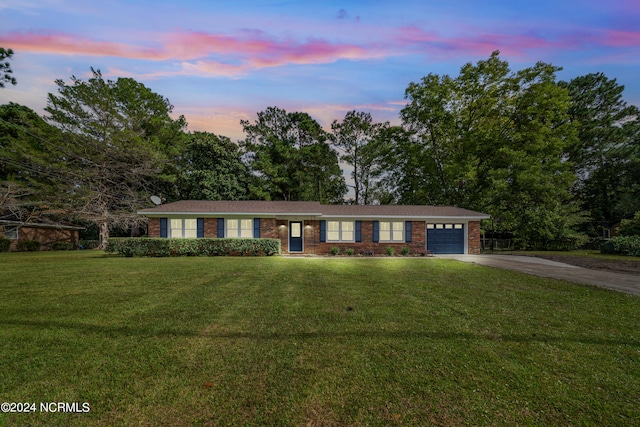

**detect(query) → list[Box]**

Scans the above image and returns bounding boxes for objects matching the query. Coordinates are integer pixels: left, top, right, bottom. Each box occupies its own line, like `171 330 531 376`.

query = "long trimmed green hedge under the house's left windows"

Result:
105 237 280 257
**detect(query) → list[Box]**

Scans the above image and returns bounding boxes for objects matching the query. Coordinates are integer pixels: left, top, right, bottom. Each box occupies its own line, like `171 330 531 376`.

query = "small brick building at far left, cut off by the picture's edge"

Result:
0 220 84 251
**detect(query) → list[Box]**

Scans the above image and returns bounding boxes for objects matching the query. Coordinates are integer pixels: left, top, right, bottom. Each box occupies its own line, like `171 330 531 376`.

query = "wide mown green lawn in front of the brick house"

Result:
0 251 640 426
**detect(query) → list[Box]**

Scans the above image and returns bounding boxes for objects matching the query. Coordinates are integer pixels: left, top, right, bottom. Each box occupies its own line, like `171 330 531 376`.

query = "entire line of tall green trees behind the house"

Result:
0 49 640 248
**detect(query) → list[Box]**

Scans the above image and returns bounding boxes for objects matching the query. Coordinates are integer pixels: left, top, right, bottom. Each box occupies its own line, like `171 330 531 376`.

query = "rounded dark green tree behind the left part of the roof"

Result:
176 132 249 200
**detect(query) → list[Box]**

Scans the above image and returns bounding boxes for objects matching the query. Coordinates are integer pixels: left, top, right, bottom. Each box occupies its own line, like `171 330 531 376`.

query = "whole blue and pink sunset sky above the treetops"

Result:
0 0 640 141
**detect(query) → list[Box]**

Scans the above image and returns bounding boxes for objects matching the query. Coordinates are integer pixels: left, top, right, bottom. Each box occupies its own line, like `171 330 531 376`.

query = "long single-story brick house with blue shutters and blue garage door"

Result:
138 200 489 255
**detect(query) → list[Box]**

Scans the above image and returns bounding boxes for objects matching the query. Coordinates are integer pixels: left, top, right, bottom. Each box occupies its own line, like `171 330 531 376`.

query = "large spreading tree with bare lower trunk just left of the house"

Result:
45 69 185 247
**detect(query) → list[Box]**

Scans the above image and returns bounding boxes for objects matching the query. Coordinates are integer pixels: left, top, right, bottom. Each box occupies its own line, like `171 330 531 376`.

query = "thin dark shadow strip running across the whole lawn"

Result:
0 320 640 348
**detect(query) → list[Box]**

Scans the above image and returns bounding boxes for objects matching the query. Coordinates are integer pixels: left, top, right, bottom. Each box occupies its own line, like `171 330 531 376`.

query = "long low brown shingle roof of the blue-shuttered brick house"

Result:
138 200 489 219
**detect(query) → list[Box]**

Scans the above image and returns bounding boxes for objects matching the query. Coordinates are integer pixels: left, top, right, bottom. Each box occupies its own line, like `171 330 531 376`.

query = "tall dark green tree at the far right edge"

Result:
559 73 640 231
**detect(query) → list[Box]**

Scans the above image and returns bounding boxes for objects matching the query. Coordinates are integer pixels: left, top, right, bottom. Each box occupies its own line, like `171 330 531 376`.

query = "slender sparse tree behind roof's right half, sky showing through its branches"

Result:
331 110 389 205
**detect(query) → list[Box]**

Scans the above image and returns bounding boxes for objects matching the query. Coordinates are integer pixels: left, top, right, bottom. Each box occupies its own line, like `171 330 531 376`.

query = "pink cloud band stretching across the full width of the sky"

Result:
0 22 640 82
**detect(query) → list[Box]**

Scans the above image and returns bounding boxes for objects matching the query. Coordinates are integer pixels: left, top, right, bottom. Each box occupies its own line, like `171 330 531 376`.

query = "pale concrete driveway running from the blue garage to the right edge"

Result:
436 255 640 296
